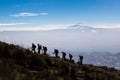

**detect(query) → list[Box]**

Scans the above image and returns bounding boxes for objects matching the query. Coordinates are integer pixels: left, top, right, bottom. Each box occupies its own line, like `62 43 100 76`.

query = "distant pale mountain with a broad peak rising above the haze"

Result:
49 24 120 33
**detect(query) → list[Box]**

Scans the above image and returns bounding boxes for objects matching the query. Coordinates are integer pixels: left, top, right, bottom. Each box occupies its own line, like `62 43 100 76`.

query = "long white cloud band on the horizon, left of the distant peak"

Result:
0 25 70 31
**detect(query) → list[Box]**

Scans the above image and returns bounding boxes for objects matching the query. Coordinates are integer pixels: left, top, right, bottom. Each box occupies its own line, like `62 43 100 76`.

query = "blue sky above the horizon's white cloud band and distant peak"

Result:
0 0 120 28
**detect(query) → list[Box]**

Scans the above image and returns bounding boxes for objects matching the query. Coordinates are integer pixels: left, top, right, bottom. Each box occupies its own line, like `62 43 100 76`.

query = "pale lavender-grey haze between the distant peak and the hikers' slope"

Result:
0 26 120 53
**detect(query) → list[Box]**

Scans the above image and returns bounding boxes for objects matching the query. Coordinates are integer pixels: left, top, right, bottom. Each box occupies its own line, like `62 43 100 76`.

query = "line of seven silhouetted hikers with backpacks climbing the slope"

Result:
31 43 83 65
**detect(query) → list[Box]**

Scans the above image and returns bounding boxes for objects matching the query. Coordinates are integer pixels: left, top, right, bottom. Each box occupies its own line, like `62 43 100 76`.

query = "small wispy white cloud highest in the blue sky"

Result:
10 12 48 17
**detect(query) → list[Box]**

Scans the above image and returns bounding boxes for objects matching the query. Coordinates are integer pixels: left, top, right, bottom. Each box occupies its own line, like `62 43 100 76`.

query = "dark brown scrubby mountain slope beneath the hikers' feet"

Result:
0 42 120 80
